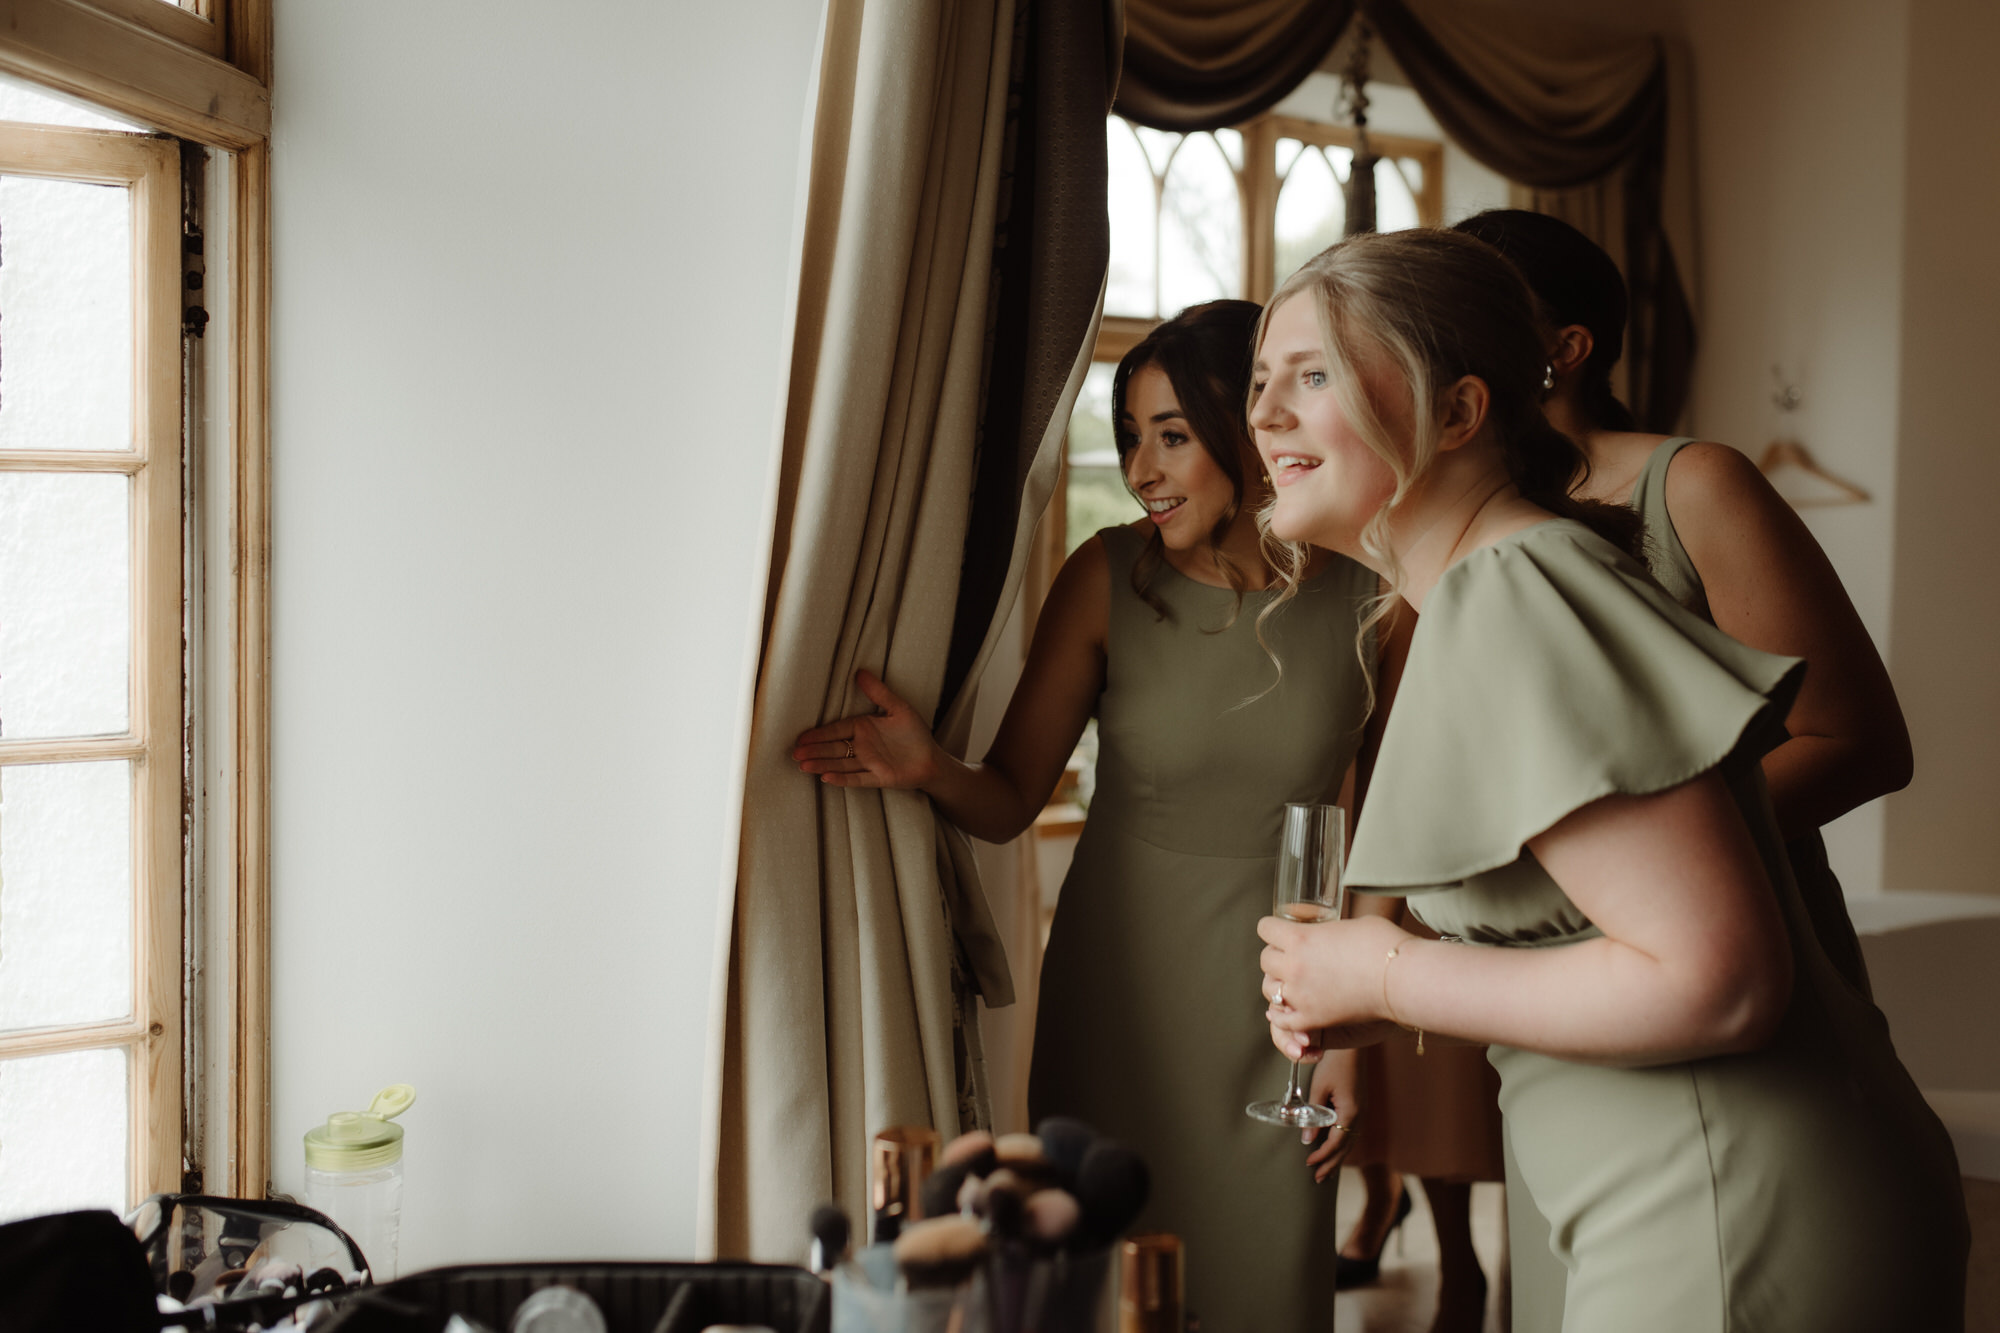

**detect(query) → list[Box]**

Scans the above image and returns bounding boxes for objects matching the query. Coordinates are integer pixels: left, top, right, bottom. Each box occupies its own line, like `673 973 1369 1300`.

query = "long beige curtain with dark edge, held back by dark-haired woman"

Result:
700 0 1108 1261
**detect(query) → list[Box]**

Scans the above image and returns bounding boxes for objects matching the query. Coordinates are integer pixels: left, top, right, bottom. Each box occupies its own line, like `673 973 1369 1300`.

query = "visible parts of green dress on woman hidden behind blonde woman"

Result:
1508 434 1896 1333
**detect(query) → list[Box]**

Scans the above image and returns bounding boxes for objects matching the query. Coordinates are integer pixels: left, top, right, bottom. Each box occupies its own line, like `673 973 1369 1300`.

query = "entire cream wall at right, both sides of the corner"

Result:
1684 0 2000 895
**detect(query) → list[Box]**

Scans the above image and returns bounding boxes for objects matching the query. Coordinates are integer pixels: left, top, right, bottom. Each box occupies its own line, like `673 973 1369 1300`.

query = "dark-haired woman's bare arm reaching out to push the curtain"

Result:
792 536 1110 843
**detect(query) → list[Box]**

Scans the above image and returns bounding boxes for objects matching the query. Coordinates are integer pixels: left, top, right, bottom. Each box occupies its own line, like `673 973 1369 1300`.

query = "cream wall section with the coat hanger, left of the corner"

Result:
1686 0 1922 895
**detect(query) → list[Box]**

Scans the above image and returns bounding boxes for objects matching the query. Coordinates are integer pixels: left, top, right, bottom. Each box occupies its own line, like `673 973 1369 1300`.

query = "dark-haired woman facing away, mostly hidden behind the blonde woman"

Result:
1452 208 1912 1333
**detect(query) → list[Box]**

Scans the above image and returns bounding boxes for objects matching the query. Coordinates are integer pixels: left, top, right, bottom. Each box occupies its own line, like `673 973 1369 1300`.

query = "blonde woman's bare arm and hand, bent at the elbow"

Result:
1258 775 1792 1065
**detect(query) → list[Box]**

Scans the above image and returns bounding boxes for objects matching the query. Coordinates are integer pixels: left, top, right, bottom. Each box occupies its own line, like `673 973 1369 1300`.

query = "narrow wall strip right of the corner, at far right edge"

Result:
1886 0 2000 892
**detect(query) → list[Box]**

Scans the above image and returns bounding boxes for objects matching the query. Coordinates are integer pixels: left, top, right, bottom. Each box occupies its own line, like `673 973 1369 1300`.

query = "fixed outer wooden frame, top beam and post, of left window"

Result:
0 0 270 1197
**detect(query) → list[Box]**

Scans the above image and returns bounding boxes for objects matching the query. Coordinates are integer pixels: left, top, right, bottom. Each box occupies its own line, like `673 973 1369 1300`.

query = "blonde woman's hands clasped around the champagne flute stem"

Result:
1256 904 1416 1061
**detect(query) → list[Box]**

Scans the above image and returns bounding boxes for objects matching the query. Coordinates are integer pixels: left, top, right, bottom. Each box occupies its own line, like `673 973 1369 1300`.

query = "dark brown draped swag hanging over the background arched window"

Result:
1114 0 1694 432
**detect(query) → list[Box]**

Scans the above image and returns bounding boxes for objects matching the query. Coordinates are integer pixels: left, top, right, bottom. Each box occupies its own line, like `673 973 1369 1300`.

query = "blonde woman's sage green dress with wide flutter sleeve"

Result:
1348 520 1968 1333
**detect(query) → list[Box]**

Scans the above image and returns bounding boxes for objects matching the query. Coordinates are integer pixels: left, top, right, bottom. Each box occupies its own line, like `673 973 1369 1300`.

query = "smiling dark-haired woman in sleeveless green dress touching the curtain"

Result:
794 300 1376 1333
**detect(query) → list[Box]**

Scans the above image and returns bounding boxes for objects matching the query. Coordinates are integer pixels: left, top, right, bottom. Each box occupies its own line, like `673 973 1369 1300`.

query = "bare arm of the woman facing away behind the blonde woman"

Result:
1666 444 1912 839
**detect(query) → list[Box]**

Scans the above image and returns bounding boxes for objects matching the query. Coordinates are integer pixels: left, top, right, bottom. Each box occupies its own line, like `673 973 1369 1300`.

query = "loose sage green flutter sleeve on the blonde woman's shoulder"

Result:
1348 518 1804 895
